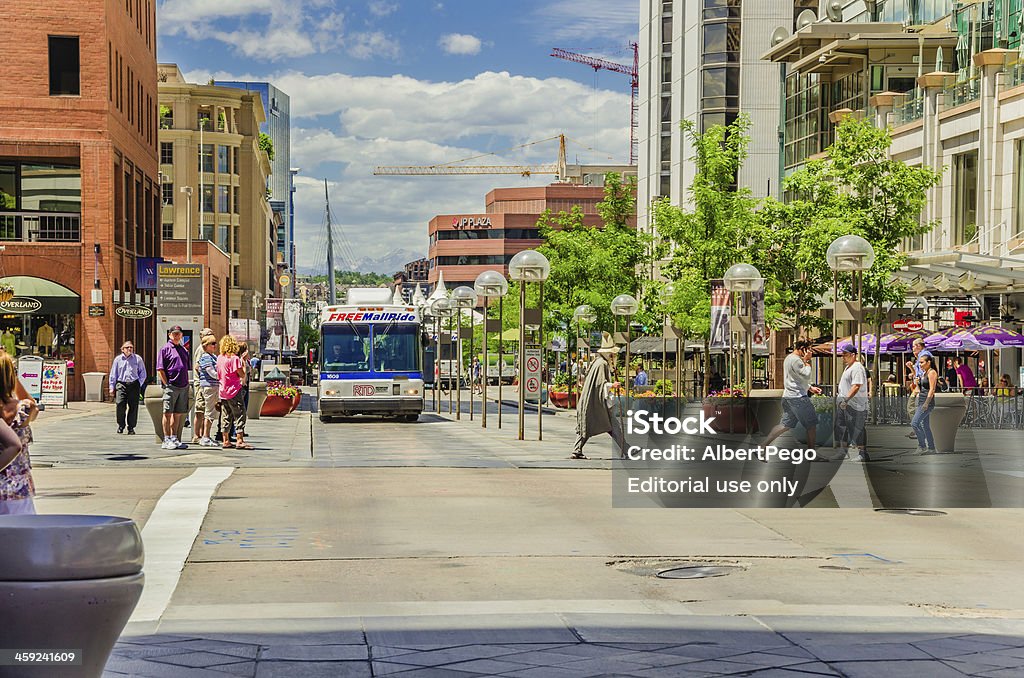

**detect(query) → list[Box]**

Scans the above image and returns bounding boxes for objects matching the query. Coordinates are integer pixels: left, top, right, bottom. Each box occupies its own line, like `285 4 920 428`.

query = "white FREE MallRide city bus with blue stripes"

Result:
317 288 423 421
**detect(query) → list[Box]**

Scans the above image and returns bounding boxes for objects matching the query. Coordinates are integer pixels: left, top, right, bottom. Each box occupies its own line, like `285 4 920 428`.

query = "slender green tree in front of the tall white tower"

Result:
654 116 763 395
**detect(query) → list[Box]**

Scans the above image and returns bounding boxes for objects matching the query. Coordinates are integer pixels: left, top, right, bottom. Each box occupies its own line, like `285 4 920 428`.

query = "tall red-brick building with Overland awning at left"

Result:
0 0 161 399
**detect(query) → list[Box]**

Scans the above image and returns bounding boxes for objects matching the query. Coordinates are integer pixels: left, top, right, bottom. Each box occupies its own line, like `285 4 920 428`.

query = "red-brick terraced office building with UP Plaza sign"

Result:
427 183 604 288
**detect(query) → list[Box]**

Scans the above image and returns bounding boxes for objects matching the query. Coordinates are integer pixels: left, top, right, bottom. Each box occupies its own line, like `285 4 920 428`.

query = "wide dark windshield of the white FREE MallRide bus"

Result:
321 323 420 373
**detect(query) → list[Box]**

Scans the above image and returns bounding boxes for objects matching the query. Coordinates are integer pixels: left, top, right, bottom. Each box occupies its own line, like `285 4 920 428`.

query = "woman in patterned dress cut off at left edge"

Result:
0 351 39 515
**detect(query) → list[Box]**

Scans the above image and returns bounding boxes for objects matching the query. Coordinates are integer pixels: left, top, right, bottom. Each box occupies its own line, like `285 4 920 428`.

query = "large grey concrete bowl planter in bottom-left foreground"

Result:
0 515 144 678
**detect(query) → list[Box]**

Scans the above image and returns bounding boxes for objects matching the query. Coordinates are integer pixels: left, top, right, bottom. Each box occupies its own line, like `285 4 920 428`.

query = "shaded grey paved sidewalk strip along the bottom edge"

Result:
103 612 1024 678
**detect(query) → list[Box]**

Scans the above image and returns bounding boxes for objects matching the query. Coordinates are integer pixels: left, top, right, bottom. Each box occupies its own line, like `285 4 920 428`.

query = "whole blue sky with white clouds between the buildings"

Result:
158 0 639 274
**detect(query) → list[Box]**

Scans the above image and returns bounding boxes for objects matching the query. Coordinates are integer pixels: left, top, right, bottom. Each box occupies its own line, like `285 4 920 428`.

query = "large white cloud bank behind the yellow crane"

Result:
185 71 630 267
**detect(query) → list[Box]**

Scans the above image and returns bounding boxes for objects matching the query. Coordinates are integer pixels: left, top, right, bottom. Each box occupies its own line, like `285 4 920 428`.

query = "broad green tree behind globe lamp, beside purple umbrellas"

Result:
761 117 941 334
